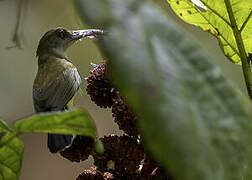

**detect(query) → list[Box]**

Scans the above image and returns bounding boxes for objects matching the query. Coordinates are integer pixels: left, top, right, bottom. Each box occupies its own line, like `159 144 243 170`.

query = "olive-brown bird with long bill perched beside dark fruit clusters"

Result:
33 27 103 153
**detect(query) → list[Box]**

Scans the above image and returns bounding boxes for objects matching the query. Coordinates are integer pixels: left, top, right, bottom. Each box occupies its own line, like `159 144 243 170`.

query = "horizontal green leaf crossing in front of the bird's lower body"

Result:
14 109 96 138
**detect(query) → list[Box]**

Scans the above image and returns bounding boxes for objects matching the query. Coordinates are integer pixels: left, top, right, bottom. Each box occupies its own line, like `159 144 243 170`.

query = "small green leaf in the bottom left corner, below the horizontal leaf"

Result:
0 133 24 180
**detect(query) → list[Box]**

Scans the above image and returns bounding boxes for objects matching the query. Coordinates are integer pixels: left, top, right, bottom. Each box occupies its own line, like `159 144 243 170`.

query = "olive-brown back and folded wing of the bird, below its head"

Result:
33 57 81 112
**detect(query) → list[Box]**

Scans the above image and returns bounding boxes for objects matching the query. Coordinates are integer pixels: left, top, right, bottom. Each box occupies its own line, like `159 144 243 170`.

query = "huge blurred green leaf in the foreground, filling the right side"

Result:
76 0 252 180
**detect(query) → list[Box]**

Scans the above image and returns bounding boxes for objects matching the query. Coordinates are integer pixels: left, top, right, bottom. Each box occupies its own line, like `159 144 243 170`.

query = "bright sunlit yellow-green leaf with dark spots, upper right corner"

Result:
167 0 252 64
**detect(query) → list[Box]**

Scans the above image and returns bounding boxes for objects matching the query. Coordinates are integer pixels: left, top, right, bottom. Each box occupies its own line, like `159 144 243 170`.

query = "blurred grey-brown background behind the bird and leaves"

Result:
0 0 246 180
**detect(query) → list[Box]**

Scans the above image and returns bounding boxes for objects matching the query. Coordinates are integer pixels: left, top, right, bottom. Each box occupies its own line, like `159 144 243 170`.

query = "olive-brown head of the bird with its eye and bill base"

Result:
37 28 83 58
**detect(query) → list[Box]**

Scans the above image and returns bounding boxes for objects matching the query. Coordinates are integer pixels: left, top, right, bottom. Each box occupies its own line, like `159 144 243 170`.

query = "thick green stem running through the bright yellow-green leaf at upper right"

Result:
225 0 252 99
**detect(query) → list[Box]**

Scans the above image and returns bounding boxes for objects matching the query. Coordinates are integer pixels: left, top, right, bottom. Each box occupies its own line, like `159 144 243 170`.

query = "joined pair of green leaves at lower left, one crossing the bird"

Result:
0 109 96 180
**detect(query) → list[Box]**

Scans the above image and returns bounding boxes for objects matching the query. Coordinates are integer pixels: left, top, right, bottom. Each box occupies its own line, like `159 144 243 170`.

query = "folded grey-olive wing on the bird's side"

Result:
33 68 81 112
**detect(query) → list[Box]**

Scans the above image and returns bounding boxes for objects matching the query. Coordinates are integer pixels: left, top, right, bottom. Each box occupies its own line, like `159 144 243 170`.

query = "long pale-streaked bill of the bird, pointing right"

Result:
71 29 105 40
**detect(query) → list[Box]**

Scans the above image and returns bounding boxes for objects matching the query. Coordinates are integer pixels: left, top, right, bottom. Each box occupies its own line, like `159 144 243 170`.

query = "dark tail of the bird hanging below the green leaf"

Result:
47 134 73 153
